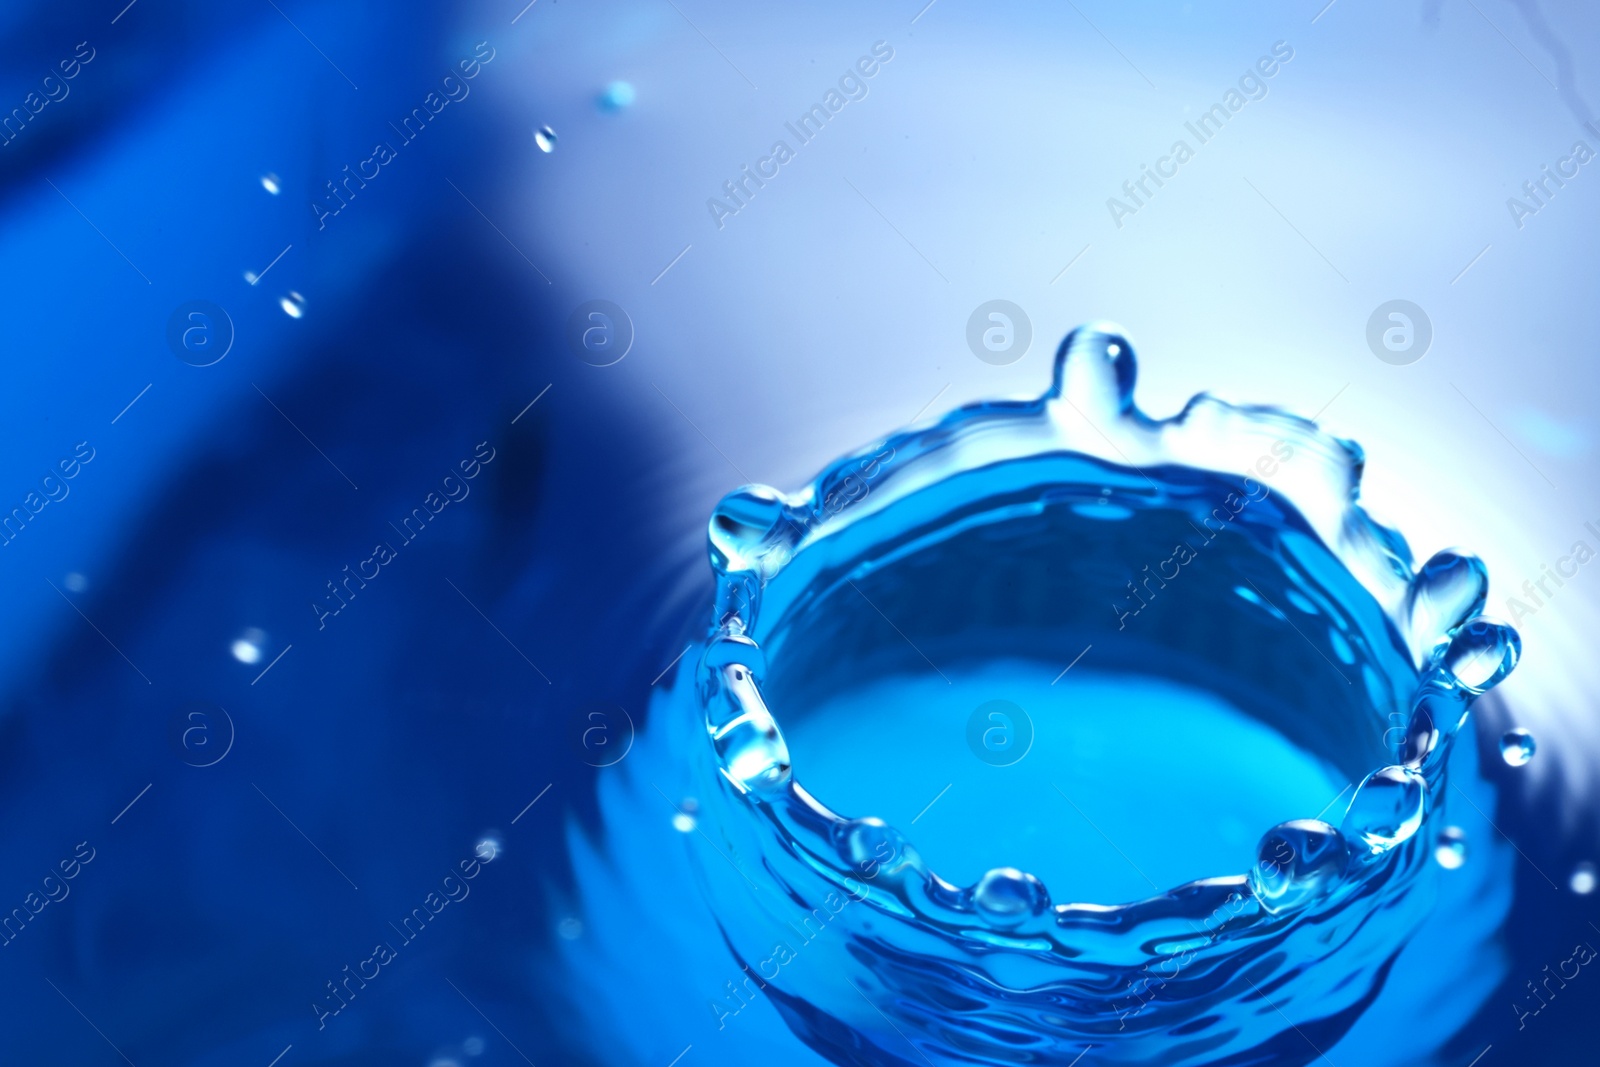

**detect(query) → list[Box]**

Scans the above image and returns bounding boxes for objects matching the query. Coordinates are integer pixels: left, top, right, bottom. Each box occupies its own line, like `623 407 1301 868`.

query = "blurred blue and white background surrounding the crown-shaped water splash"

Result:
0 0 1600 1067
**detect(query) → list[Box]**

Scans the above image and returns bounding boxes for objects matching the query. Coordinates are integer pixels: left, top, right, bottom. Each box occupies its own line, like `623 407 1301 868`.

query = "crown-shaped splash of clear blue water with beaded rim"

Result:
574 326 1518 1064
